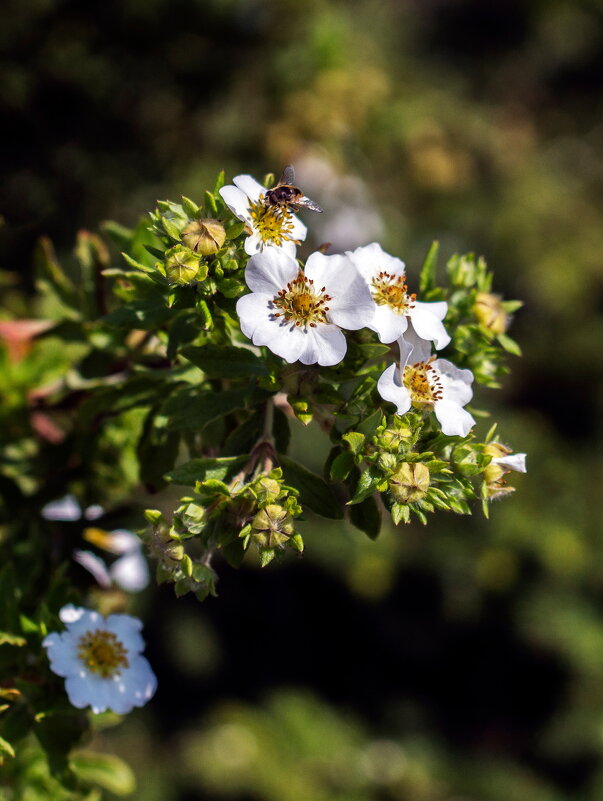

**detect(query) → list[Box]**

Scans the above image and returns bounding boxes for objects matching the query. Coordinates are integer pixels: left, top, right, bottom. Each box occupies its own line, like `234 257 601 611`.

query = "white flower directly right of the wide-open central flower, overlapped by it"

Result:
347 242 450 350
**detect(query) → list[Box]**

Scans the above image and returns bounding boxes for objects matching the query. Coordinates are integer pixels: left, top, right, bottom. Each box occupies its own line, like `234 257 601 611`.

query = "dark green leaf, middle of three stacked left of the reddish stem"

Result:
162 387 250 431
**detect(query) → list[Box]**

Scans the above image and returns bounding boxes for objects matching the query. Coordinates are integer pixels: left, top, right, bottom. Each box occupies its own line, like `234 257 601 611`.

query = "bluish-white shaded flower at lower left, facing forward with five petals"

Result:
42 604 157 715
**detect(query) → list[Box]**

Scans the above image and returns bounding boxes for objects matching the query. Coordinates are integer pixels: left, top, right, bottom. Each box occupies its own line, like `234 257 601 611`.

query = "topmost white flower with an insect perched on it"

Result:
220 175 307 256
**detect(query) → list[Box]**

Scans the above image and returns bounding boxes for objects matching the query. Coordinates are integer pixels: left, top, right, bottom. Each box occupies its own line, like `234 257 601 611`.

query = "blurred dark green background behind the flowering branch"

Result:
0 0 603 801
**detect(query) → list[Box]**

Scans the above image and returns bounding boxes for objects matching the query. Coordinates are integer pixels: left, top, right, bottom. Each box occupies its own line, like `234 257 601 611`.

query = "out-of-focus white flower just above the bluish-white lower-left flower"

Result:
73 528 149 592
